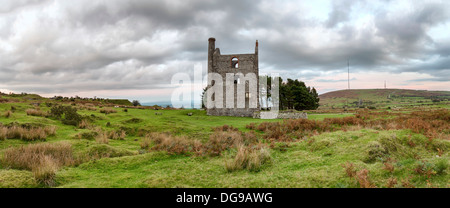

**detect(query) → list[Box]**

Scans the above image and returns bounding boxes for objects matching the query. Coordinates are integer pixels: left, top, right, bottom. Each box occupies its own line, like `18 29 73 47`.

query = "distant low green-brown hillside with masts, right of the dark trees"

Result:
319 89 450 108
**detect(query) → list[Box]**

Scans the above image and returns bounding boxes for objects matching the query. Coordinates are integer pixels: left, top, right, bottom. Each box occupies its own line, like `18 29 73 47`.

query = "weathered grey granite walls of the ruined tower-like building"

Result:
207 38 260 117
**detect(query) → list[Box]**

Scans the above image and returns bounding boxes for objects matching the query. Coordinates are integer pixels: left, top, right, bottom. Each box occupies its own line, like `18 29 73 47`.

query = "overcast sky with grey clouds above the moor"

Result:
0 0 450 102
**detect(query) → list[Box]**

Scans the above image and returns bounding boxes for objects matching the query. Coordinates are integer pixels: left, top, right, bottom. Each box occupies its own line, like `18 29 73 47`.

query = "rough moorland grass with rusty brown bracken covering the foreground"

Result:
0 97 450 187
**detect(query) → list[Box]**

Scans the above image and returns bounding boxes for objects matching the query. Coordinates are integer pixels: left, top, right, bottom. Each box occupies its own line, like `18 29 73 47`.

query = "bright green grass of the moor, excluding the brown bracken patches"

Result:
0 95 450 188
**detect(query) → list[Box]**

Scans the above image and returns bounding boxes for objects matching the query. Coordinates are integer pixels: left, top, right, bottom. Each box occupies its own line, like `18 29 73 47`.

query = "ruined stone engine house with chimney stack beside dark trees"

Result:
207 38 260 117
